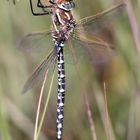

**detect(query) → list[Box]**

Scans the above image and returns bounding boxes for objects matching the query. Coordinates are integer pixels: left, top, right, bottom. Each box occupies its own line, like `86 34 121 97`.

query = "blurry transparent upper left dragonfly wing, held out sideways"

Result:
17 30 54 53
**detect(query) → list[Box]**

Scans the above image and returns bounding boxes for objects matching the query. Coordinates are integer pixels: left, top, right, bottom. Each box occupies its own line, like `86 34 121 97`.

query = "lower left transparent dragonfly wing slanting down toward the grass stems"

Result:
22 49 57 93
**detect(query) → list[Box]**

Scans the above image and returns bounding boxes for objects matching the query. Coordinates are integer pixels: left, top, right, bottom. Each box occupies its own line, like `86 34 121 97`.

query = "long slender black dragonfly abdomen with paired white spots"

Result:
57 43 65 140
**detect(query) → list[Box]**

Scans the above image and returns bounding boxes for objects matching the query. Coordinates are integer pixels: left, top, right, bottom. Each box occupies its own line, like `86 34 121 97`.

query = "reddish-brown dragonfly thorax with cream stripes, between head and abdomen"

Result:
52 3 76 41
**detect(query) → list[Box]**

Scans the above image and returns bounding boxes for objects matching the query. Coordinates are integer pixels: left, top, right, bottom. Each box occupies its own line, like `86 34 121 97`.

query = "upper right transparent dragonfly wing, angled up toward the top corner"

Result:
75 3 125 35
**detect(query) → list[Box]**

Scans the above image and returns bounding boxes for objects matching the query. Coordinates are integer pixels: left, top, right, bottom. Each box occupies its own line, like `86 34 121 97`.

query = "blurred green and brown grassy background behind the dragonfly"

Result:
0 0 140 140
